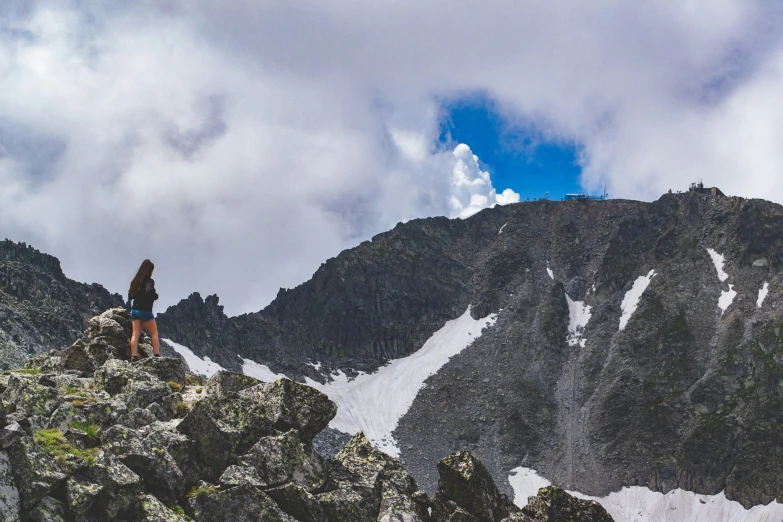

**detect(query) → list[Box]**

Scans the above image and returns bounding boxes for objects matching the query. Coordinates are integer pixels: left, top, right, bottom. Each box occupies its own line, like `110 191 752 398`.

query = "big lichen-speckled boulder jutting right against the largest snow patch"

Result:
239 379 337 442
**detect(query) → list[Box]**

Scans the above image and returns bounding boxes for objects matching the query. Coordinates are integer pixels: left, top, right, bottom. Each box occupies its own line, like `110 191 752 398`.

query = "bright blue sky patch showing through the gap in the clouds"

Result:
438 95 583 201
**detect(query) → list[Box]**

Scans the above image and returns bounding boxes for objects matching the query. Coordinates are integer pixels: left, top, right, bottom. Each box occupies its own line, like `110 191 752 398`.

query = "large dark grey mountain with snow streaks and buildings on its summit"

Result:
160 194 783 506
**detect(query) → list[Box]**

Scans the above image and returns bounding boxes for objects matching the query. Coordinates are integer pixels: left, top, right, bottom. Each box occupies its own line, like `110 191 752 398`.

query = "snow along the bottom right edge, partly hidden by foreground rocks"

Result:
508 467 783 522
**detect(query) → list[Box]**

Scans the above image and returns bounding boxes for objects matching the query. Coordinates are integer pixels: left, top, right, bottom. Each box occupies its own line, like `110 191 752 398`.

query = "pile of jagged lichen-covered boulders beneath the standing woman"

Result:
0 309 611 522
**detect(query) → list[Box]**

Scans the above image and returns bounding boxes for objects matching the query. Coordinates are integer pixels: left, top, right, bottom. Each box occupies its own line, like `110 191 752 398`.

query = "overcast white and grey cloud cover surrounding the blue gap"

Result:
0 0 783 314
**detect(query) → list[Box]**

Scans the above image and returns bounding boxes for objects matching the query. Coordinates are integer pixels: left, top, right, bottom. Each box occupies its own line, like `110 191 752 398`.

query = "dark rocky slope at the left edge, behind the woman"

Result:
0 240 122 369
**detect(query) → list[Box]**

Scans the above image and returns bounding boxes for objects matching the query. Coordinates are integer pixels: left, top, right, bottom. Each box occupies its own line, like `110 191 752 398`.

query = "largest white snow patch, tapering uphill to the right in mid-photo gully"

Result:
305 307 497 457
